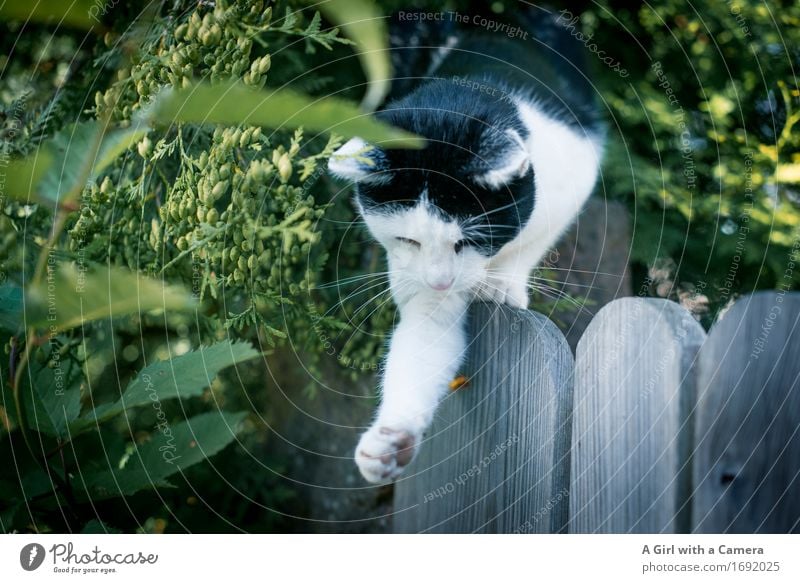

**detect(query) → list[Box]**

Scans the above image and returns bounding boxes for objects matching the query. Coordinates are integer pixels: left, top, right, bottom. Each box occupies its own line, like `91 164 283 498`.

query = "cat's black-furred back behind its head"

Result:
392 8 602 132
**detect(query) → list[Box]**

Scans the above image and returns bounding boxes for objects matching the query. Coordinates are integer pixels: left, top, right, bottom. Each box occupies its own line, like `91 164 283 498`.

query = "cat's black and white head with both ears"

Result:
329 81 534 291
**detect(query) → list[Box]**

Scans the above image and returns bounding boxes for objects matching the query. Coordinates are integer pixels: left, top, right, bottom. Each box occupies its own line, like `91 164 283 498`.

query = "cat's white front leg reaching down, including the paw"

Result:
355 293 469 483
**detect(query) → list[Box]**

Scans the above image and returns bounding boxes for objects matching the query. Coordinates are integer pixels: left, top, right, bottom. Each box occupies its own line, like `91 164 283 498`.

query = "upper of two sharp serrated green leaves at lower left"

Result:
70 340 260 434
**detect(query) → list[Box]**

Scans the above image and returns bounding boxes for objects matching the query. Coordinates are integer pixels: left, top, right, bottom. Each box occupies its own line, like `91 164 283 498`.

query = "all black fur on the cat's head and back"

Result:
356 8 599 255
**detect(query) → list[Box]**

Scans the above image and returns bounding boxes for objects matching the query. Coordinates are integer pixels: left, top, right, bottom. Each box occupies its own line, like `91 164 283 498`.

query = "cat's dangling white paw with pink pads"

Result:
356 425 420 484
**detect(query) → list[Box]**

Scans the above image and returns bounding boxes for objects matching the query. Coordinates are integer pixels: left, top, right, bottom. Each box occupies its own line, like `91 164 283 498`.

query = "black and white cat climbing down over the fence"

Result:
329 9 604 483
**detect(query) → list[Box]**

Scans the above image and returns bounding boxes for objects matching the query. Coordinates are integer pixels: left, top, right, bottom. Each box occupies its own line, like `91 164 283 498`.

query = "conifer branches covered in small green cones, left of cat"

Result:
61 1 394 376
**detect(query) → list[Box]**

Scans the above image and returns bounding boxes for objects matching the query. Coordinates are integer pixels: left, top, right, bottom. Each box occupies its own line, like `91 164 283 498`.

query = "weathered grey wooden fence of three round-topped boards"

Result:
394 292 800 533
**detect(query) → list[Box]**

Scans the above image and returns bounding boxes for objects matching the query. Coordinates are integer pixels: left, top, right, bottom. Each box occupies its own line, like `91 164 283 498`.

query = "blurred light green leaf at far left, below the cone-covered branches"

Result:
26 264 196 332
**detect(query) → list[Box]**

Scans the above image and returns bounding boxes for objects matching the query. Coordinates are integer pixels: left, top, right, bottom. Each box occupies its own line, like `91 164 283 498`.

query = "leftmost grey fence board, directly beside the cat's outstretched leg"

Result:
394 304 574 533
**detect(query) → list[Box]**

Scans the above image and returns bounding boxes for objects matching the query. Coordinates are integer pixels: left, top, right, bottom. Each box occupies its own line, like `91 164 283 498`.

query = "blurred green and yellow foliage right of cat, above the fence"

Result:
580 0 800 316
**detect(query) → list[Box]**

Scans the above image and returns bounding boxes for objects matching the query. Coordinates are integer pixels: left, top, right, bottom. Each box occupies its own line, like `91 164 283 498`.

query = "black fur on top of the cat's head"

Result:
358 80 535 254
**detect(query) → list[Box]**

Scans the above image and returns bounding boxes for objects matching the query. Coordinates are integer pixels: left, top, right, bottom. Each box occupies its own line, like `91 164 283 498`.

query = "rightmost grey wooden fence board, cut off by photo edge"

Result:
693 292 800 533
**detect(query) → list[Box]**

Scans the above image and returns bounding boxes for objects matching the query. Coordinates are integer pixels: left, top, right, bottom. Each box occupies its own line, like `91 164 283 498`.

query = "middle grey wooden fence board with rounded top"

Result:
569 298 705 533
